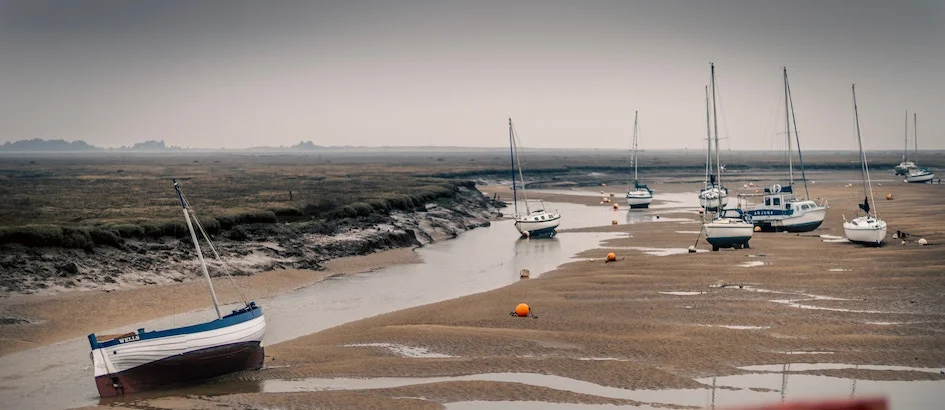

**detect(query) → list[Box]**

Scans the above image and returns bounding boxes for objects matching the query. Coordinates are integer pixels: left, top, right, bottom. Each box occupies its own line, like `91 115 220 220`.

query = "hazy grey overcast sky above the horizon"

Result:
0 0 945 150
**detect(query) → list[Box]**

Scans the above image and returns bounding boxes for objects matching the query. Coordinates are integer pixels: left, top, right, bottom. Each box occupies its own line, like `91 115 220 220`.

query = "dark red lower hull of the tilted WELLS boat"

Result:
95 342 265 398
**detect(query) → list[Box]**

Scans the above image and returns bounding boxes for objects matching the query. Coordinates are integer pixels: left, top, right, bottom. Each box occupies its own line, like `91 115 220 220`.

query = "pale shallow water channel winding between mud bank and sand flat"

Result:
0 198 656 408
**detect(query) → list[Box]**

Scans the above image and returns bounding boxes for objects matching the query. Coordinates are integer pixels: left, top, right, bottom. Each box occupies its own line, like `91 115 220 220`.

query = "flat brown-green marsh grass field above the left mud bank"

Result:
0 155 472 249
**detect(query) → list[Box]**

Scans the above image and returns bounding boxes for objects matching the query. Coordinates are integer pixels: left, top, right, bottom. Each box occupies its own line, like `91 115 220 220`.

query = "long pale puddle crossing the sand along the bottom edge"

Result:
261 363 945 410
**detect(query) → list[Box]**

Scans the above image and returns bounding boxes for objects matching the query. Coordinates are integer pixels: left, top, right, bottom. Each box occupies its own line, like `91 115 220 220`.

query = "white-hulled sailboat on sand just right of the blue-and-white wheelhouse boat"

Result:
843 84 886 246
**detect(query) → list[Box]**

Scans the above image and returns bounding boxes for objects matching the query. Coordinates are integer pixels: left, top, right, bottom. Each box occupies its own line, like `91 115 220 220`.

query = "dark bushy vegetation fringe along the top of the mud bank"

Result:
0 181 475 251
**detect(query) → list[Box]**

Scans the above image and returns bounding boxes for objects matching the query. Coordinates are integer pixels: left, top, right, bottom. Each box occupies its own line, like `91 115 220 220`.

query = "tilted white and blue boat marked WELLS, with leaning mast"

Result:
88 180 266 397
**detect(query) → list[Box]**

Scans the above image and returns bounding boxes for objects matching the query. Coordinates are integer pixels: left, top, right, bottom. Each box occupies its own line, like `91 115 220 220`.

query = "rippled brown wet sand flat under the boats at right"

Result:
81 182 945 409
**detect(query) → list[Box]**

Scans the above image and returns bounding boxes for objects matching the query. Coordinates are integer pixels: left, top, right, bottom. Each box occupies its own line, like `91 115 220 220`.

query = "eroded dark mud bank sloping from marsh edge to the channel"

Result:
0 186 497 296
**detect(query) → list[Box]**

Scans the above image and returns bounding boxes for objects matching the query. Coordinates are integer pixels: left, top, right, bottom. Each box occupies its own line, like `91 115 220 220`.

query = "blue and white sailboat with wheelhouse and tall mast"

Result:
743 67 827 232
